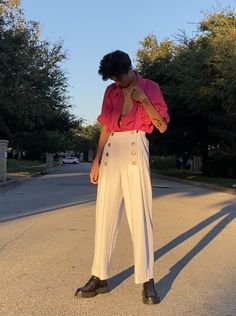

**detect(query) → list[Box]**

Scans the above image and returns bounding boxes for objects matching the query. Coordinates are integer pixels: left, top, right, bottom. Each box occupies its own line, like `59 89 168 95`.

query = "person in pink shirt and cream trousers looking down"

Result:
75 50 169 304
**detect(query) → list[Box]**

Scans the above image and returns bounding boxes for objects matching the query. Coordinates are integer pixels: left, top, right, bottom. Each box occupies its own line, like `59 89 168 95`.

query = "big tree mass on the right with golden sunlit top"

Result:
137 10 236 172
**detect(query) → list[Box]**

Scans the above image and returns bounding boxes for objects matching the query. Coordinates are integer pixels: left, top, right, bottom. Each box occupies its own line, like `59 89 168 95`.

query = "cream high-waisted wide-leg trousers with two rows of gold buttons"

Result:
92 130 154 283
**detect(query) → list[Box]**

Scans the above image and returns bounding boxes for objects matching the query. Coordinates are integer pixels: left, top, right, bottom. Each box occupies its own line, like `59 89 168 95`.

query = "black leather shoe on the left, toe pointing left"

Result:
75 275 110 297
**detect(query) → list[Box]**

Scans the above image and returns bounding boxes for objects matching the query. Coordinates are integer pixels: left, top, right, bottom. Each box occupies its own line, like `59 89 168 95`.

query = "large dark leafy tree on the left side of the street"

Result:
0 1 82 157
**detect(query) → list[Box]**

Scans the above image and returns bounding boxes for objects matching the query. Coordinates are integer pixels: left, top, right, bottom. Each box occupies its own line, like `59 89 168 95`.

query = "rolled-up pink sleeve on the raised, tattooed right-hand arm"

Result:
145 81 170 123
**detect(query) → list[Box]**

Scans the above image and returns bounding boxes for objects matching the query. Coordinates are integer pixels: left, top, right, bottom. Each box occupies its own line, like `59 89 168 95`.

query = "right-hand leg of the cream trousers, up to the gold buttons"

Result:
121 131 154 283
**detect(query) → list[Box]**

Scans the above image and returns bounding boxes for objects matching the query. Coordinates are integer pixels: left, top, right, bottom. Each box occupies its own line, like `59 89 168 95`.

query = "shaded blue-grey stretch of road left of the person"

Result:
0 163 96 222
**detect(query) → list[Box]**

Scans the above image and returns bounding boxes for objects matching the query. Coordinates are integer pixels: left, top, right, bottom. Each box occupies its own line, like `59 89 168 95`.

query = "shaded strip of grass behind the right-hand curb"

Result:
151 169 236 188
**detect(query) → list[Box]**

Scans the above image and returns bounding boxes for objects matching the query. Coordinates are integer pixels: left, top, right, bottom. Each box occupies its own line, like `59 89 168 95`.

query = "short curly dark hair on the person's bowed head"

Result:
98 50 131 80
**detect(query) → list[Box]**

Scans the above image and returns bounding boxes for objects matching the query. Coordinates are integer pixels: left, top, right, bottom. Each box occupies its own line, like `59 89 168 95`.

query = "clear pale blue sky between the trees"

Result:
21 0 236 124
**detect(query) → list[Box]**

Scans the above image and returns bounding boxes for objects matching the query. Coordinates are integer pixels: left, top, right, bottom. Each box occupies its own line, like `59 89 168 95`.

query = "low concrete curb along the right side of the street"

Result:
151 173 236 195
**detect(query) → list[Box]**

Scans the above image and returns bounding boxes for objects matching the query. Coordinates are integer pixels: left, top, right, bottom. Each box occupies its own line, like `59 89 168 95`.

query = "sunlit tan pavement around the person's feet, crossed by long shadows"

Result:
0 178 236 316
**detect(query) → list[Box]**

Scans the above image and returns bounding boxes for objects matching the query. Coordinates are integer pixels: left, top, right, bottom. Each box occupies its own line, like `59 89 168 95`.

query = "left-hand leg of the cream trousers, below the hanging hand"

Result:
92 148 123 280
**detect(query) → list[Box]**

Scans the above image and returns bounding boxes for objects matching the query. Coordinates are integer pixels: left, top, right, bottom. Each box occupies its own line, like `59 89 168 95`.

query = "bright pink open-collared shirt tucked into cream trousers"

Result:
97 74 170 133
